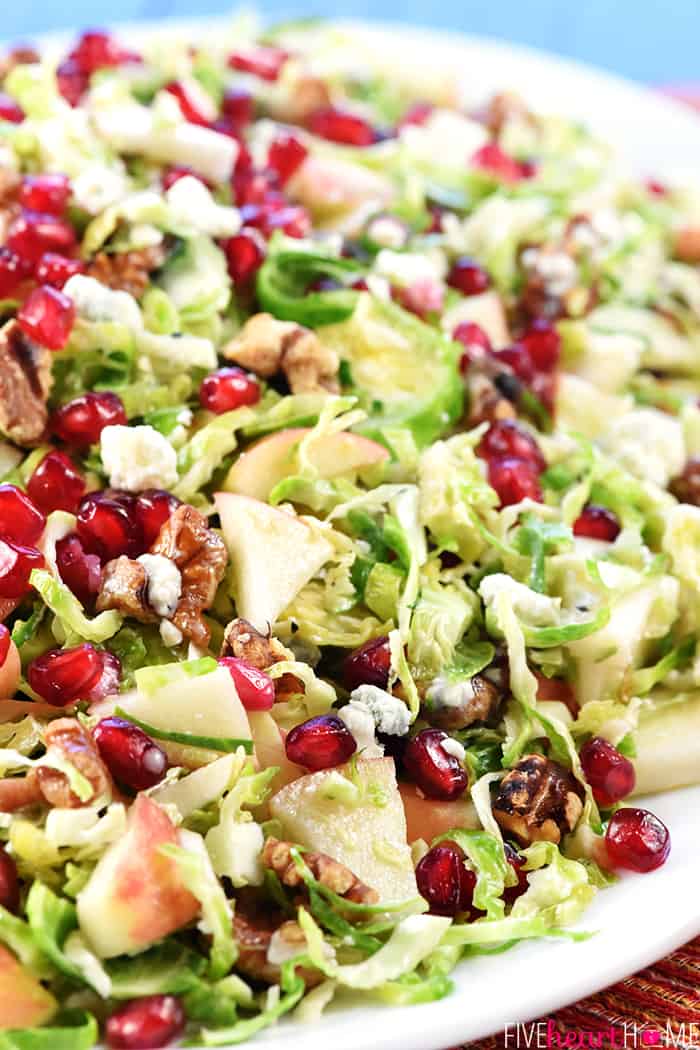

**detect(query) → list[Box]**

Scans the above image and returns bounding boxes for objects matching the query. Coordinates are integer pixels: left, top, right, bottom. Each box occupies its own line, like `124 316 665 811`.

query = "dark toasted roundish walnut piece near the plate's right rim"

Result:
493 755 584 845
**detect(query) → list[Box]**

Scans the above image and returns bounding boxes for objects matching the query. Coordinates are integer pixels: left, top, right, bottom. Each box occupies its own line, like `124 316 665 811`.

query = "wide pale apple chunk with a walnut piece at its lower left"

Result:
270 758 418 901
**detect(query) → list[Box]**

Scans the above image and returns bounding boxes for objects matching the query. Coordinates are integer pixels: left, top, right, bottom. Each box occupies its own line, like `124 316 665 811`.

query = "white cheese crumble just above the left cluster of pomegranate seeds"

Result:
100 426 177 492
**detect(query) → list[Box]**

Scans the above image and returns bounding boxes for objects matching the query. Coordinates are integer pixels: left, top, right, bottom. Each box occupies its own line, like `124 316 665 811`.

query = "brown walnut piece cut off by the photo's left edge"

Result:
0 320 51 445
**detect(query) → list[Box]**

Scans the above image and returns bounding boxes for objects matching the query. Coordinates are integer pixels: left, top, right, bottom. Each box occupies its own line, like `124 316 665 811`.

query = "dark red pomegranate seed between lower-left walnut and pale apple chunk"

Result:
92 717 168 791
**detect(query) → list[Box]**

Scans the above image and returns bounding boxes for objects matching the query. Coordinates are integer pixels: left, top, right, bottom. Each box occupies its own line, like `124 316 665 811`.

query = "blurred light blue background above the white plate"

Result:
5 0 700 84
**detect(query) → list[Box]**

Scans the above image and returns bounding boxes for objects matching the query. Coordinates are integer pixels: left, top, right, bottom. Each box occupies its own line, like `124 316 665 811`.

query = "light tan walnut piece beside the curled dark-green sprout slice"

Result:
222 314 339 394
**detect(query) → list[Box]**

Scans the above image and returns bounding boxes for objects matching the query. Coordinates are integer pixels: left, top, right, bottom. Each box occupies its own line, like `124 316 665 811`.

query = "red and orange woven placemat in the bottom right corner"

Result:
469 938 700 1050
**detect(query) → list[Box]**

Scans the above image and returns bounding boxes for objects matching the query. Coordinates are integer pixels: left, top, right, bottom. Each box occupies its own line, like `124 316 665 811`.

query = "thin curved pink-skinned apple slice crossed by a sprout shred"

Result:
224 426 389 500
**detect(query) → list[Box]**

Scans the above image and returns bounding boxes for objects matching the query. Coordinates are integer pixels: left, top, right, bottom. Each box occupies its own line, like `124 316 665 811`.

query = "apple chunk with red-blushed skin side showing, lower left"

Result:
77 795 199 959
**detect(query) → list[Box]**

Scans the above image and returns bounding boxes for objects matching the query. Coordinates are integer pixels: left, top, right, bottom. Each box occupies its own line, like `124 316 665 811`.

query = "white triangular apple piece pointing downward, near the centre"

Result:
214 492 333 632
